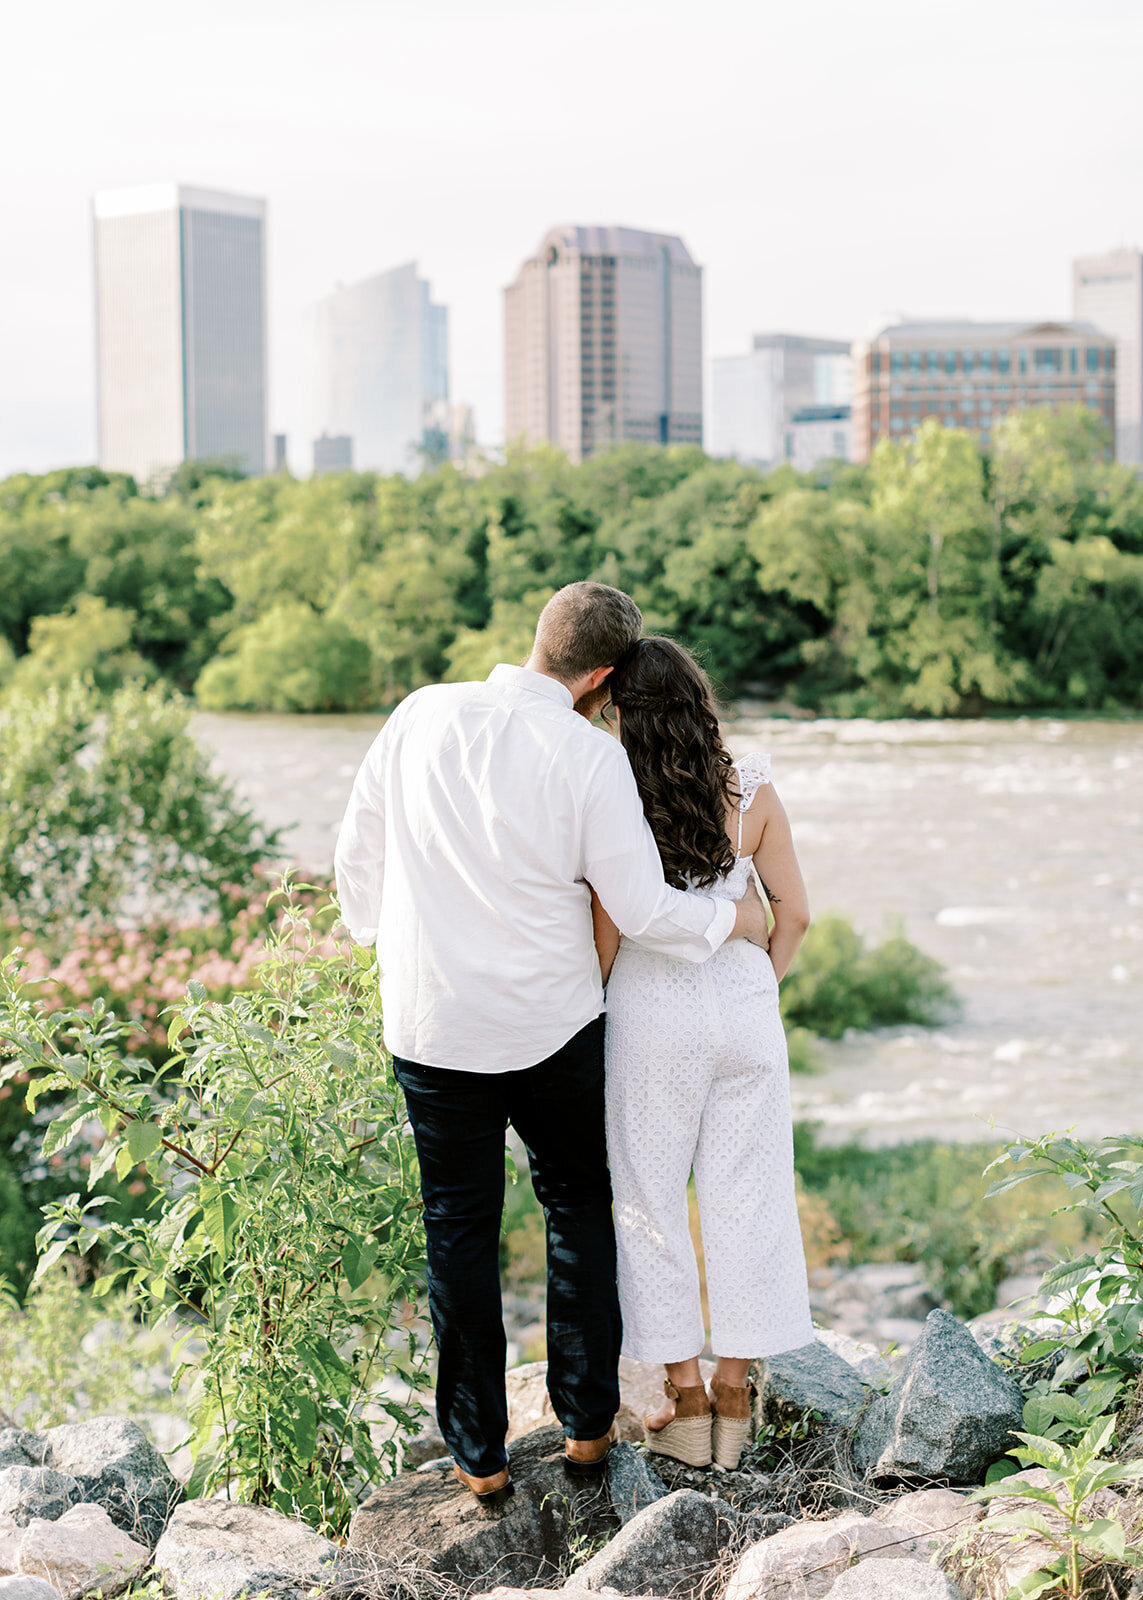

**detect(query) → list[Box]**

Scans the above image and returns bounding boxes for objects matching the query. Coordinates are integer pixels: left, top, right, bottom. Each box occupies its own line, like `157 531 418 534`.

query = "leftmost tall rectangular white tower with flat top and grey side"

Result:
94 184 267 482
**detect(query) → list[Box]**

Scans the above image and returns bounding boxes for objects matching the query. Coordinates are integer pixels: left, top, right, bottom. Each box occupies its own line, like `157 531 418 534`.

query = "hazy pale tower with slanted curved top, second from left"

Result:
309 262 448 472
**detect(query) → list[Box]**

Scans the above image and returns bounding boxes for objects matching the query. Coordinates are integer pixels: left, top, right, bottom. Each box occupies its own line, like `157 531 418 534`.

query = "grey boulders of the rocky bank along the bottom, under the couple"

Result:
0 1309 1143 1600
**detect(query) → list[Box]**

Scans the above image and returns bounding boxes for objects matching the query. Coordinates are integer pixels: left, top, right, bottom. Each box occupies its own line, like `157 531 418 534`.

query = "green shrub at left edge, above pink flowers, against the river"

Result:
0 680 275 939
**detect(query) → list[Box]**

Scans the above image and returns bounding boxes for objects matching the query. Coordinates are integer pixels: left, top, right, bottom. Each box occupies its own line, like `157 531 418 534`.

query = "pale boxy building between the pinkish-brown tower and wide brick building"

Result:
709 333 852 467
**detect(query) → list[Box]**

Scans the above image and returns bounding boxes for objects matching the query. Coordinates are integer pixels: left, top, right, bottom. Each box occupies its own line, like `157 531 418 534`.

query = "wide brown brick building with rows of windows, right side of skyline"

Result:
853 322 1116 461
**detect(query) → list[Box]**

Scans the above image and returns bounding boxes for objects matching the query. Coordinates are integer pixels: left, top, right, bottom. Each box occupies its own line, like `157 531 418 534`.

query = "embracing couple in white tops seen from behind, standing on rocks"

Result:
336 582 813 1504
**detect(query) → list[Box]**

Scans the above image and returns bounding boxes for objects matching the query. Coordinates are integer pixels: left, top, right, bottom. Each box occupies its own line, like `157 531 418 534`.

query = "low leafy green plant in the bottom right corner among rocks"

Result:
969 1416 1143 1600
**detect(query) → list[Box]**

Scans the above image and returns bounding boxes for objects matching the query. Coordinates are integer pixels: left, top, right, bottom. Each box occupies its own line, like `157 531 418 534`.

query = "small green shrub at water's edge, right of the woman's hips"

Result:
781 917 957 1038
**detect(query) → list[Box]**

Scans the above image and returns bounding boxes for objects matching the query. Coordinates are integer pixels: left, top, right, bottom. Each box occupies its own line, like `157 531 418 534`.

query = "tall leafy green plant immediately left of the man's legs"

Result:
0 907 424 1531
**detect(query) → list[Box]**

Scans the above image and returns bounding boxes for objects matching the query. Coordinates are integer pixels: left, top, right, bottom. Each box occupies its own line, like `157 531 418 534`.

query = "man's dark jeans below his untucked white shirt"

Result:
394 1016 621 1477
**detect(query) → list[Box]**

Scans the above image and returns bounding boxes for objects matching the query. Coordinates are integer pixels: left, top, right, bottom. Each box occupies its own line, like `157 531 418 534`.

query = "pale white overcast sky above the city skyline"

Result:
0 0 1143 475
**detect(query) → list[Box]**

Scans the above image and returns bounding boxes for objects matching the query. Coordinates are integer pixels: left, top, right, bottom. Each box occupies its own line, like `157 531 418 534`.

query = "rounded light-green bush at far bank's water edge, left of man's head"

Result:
195 600 375 710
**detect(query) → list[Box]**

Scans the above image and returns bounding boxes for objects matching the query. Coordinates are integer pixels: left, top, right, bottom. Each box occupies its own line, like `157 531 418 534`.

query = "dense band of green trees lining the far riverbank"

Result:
0 410 1143 715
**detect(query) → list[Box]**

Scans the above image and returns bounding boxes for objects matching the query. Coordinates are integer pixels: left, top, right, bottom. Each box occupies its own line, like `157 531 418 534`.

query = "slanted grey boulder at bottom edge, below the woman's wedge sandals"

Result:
570 1490 736 1595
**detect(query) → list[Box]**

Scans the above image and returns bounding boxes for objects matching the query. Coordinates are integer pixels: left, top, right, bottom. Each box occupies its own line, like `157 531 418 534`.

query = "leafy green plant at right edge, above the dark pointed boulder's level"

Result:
988 1133 1143 1387
